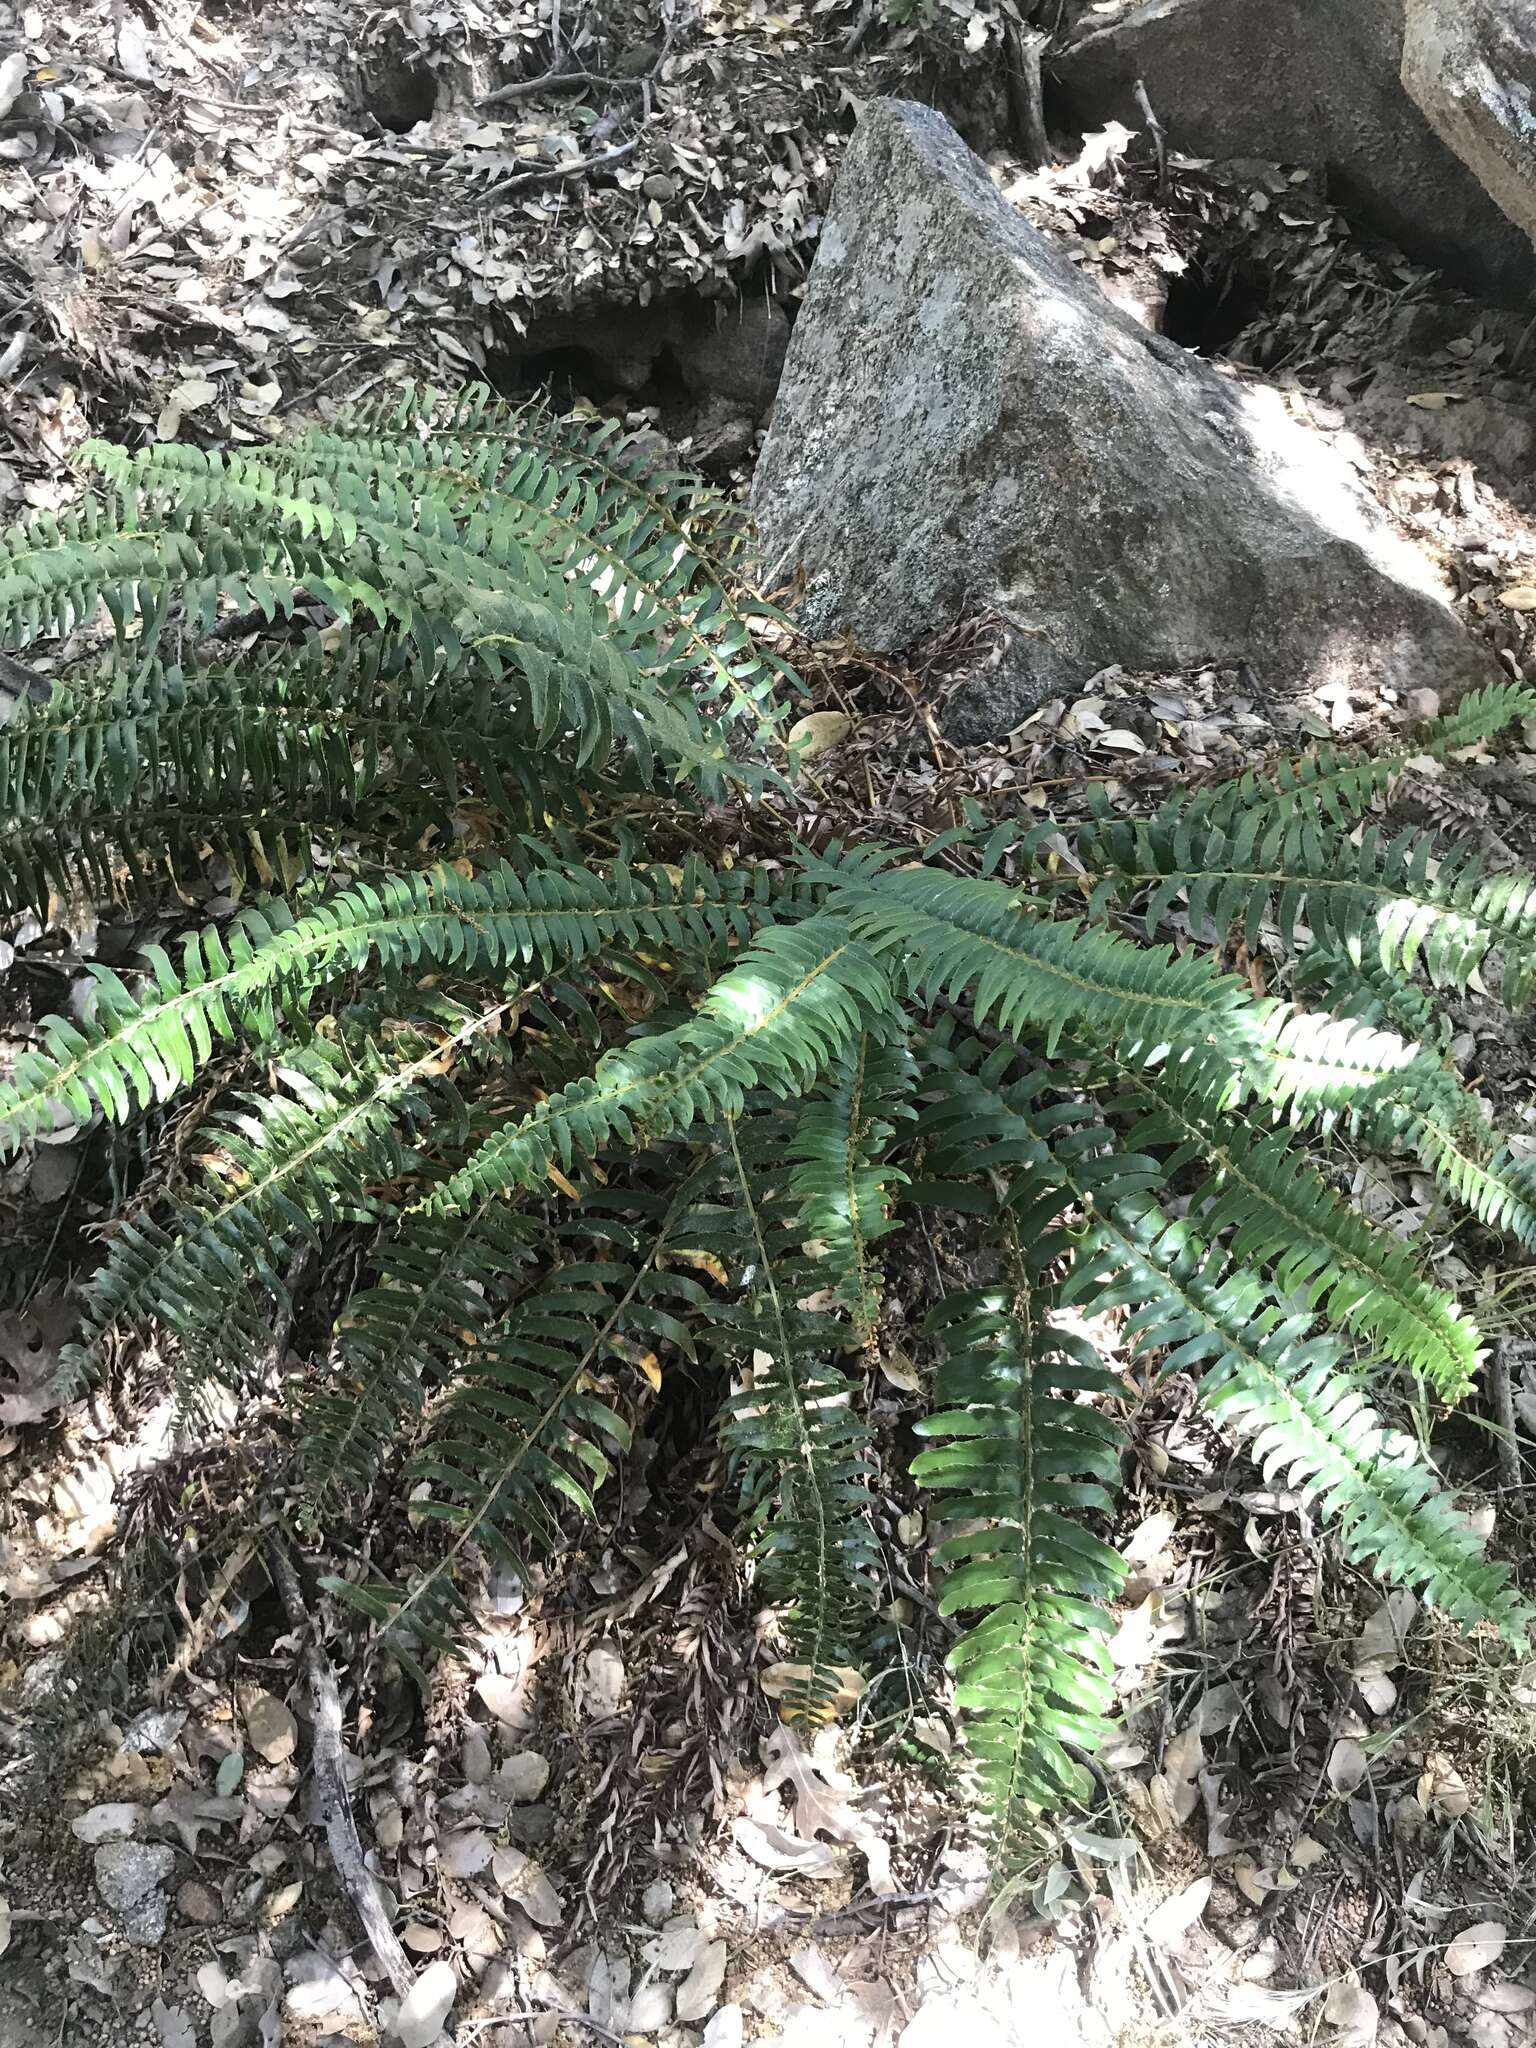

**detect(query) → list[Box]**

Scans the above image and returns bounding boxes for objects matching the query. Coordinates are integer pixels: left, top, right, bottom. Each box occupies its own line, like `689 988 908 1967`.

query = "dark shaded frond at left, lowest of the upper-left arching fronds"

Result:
0 635 618 913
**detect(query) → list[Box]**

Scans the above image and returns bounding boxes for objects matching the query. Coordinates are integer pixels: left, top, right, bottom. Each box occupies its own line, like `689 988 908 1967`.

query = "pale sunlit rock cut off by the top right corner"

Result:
1403 0 1536 245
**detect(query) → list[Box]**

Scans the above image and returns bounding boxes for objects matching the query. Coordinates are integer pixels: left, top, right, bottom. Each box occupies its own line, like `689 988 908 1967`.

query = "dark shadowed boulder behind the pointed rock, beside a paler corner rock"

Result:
1053 0 1536 301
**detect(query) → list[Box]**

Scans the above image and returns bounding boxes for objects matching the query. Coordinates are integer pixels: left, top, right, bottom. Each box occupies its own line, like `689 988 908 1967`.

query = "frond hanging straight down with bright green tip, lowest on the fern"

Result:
911 1178 1126 1876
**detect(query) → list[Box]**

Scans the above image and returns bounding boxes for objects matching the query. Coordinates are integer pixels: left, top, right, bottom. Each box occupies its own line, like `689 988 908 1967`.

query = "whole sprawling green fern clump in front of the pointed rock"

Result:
0 393 1536 1870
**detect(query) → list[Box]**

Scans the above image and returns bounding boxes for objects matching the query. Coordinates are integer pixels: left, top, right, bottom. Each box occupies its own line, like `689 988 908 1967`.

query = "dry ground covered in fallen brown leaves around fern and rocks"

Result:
0 0 1536 2048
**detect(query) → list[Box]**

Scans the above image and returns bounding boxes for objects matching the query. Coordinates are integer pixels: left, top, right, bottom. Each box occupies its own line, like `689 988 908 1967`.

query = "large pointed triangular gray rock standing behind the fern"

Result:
754 100 1491 737
